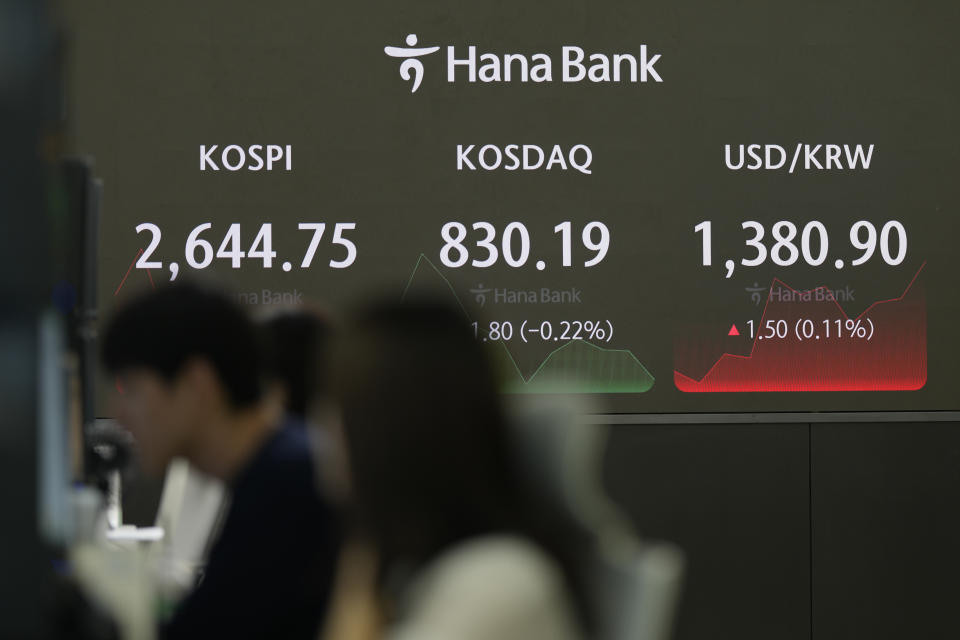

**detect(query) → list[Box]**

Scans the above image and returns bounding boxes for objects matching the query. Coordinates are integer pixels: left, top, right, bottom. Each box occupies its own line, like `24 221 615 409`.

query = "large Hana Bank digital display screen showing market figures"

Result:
70 0 960 413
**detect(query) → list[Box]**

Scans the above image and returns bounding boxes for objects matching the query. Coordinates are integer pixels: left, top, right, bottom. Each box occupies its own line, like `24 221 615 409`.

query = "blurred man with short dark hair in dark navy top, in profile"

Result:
103 284 338 639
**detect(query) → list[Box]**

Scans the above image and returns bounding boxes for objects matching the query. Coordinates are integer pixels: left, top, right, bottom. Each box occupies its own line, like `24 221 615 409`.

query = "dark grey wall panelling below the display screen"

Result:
606 423 960 640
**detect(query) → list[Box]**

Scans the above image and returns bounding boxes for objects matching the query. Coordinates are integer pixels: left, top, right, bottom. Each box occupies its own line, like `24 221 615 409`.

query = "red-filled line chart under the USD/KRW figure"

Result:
674 263 927 393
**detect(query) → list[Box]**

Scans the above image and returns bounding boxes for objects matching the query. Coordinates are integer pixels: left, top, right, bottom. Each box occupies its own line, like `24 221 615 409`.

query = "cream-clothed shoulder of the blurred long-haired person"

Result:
391 535 579 640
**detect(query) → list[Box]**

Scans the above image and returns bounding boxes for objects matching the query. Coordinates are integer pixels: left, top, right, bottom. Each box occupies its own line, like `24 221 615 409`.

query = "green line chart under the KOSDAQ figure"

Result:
400 253 655 393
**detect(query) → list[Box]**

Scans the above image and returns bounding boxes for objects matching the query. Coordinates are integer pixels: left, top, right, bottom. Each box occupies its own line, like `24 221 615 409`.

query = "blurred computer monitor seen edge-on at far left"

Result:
37 157 102 544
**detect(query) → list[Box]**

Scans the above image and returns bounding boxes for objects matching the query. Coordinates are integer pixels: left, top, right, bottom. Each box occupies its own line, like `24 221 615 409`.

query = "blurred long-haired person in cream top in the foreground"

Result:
326 301 590 640
